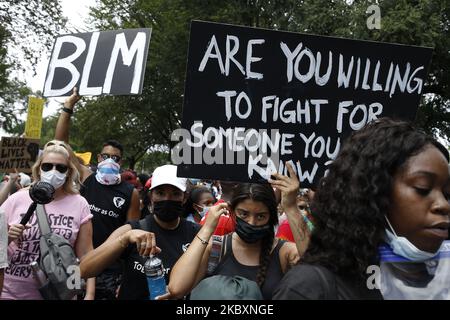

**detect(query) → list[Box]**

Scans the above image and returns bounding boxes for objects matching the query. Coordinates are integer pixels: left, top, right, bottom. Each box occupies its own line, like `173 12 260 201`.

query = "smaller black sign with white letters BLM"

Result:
43 29 151 97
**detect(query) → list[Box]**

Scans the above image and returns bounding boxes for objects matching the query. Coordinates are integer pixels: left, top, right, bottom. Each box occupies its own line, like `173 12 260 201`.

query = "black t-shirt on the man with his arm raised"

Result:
80 174 133 248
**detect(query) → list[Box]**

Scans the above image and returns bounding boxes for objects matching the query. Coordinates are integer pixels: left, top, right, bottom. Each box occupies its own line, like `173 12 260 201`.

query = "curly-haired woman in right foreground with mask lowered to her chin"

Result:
274 119 450 299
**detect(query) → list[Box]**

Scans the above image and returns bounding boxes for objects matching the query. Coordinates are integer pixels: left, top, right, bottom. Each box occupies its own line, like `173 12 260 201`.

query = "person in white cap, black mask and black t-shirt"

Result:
80 165 199 300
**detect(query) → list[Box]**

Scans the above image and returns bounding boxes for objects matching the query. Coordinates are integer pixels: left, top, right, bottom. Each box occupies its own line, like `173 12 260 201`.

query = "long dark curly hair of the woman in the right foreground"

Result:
302 118 449 280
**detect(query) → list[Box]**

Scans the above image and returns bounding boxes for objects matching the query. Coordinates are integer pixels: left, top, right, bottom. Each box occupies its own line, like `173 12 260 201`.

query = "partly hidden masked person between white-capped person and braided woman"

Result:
184 186 216 224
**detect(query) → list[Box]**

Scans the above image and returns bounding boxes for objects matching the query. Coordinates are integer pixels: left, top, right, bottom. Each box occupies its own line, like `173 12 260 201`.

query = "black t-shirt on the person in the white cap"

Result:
119 215 200 300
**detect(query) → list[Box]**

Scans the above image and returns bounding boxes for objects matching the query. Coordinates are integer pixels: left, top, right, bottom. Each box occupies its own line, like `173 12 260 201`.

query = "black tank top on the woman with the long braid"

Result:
213 234 286 300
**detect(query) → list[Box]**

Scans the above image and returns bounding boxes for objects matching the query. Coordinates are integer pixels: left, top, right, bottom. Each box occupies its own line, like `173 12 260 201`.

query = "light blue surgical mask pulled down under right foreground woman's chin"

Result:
385 216 440 262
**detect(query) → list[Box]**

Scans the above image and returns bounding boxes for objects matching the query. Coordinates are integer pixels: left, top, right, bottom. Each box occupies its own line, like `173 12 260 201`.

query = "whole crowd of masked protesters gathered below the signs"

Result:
0 91 450 300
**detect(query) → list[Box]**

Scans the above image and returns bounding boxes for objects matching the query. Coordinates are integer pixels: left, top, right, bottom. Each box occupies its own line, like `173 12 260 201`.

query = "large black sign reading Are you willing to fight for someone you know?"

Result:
172 21 432 187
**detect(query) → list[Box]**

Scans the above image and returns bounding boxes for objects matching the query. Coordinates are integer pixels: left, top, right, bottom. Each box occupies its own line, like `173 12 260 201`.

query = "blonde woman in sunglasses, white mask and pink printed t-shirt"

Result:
1 142 95 300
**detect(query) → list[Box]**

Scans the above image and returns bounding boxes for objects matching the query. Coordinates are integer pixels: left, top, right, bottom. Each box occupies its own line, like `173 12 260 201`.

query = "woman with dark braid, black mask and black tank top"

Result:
168 172 299 299
